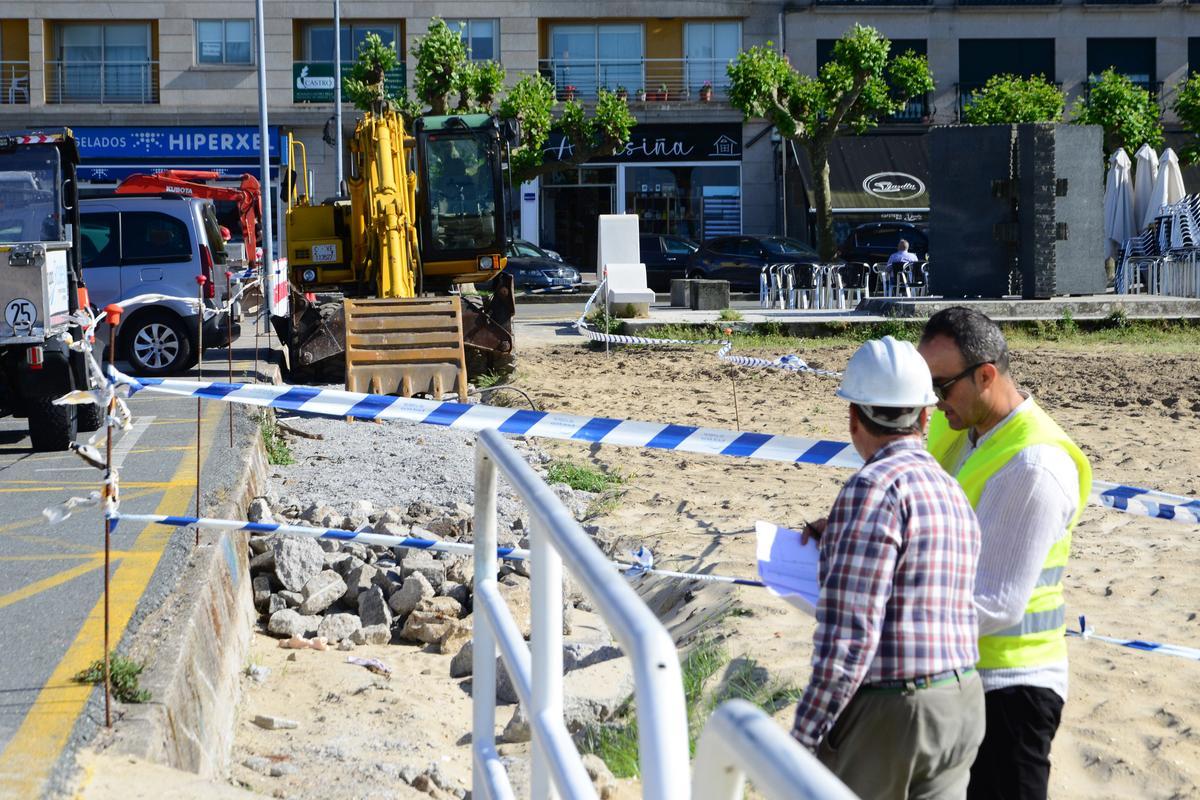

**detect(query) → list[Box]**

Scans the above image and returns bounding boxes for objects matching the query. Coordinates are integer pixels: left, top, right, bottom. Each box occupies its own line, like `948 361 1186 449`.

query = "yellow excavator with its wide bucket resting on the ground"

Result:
284 110 520 398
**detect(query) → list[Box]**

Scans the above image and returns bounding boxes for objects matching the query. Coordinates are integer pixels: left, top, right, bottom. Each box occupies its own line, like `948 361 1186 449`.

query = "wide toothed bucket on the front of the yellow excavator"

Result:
344 297 467 401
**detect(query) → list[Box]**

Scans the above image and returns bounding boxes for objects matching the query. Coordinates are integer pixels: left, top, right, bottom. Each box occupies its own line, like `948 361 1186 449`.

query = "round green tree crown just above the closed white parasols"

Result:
1075 68 1163 155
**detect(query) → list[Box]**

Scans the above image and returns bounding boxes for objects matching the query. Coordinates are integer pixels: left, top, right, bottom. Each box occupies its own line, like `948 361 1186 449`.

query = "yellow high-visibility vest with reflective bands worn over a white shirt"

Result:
929 403 1092 669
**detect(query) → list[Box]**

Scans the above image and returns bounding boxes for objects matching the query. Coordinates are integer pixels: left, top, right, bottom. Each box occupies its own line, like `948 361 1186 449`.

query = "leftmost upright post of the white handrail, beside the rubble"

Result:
470 444 496 800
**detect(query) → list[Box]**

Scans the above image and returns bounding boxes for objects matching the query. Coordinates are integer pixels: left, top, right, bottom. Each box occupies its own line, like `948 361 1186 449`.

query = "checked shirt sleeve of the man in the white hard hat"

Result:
792 475 901 750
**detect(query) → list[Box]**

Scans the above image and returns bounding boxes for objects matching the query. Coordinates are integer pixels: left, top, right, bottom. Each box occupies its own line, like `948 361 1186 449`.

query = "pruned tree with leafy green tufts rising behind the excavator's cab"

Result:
410 18 637 182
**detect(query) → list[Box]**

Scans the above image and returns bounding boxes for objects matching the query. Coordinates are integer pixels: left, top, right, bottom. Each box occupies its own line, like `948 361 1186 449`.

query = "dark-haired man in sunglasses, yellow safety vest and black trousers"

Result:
919 306 1092 800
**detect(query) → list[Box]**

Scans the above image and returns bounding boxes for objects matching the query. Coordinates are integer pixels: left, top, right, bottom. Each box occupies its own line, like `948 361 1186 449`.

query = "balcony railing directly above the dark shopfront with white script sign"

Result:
538 59 730 103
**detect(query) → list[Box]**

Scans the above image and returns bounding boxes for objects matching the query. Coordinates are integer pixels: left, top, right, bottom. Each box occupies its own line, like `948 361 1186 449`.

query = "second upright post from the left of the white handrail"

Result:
530 521 563 800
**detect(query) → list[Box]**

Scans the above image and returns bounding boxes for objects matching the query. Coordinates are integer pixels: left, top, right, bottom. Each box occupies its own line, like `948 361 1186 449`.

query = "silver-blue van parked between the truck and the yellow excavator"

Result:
79 194 241 377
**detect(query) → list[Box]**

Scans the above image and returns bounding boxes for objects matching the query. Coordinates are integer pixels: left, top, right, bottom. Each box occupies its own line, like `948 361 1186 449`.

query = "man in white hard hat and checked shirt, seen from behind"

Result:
792 336 984 800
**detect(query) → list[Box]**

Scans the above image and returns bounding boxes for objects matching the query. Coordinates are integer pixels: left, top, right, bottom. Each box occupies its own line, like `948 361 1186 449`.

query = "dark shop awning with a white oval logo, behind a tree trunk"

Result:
794 133 929 213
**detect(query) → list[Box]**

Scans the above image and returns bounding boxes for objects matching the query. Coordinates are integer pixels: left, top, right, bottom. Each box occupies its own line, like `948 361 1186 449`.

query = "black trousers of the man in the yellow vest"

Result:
967 686 1062 800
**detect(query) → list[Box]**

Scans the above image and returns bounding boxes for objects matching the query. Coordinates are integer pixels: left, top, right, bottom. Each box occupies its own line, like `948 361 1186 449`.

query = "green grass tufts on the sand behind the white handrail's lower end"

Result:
581 639 803 777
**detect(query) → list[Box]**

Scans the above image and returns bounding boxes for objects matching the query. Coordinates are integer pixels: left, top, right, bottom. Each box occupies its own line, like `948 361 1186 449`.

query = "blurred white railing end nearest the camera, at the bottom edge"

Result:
691 700 856 800
